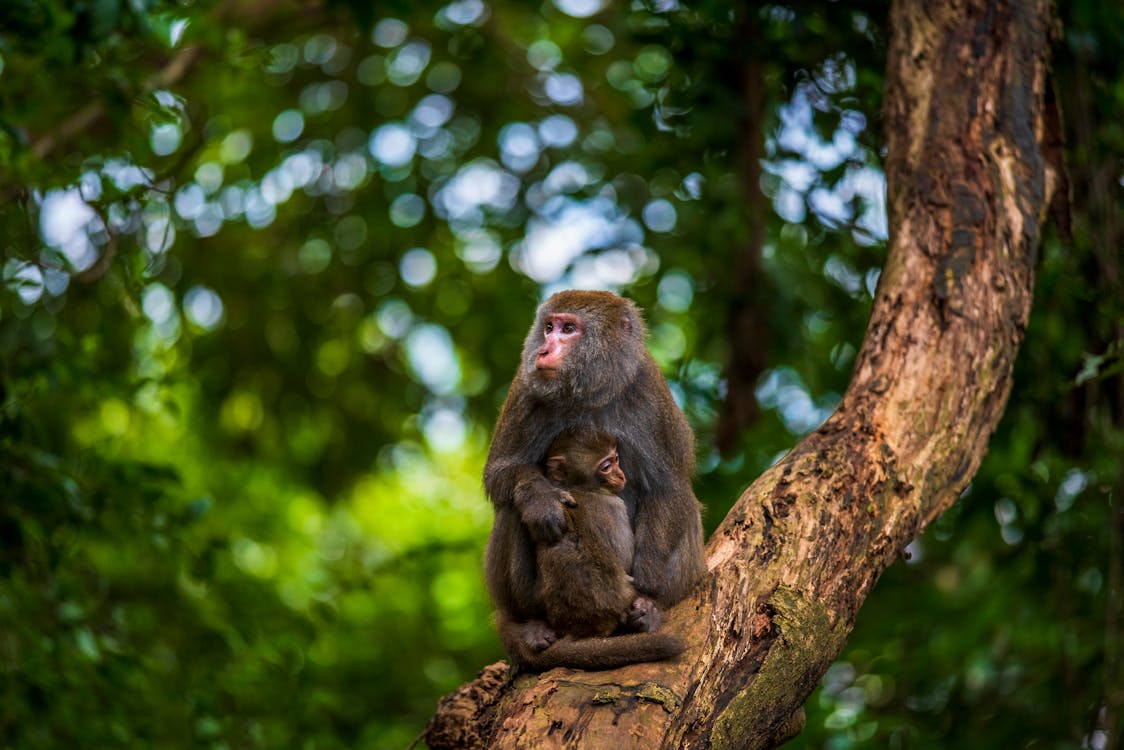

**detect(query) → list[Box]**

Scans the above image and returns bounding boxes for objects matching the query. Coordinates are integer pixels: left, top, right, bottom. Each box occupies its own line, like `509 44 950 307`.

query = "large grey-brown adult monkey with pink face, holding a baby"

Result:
484 291 706 660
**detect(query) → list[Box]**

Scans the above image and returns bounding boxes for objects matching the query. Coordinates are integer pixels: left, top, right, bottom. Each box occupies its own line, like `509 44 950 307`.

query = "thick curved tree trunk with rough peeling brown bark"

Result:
426 0 1058 748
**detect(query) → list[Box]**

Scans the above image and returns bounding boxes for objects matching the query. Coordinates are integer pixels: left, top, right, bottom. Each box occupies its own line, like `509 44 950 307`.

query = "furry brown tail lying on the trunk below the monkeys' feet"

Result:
516 633 687 671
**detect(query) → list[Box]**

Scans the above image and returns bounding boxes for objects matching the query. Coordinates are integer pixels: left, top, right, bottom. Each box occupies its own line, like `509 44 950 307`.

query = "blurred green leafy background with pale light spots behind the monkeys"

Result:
0 0 1124 748
